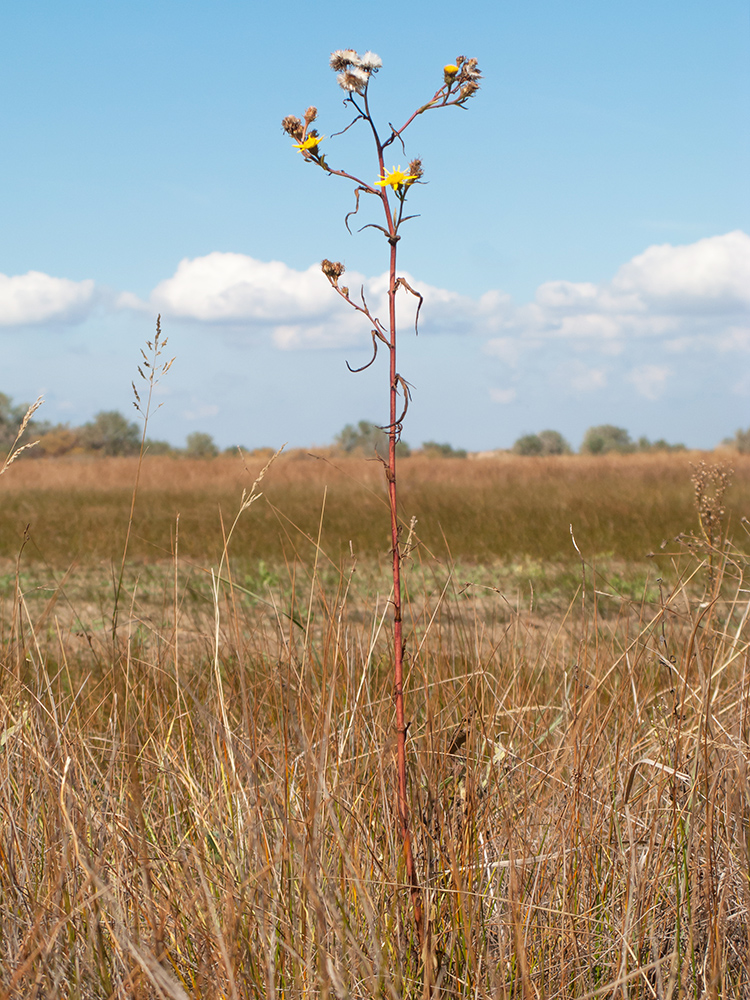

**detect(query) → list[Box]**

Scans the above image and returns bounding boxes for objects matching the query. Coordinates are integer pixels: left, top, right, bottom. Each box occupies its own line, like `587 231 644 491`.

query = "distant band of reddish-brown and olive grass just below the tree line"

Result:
0 453 750 566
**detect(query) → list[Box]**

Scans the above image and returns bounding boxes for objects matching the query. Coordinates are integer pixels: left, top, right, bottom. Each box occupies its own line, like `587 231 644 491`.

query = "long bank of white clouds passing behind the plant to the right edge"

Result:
125 231 750 376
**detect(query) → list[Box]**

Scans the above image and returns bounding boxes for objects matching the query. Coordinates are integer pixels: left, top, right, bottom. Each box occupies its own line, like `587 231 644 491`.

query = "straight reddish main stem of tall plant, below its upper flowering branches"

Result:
386 237 424 947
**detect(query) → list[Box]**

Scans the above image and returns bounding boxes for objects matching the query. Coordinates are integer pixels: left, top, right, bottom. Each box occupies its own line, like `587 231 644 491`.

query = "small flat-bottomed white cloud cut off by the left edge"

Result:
0 271 94 326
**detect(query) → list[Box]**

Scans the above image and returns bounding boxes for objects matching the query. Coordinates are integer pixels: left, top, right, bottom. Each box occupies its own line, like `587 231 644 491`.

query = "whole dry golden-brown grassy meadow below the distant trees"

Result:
0 452 750 1000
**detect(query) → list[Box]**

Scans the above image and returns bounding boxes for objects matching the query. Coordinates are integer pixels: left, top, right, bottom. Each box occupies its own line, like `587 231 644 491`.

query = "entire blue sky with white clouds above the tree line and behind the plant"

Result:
0 0 750 449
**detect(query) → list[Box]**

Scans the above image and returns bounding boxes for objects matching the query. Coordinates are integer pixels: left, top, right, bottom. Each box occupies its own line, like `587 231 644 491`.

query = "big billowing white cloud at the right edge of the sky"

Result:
476 231 750 408
